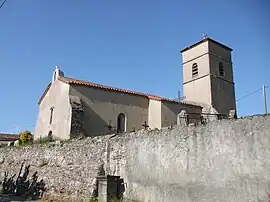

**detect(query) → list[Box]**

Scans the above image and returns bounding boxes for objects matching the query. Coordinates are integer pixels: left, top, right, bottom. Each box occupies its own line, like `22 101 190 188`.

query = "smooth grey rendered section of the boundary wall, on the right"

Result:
116 116 270 202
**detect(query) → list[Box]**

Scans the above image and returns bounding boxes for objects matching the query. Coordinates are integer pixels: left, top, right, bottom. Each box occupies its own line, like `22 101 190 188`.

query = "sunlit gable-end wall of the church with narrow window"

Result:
34 80 71 139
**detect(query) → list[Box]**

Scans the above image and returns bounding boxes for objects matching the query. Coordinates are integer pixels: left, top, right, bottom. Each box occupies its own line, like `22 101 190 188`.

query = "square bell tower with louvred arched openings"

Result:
181 36 236 114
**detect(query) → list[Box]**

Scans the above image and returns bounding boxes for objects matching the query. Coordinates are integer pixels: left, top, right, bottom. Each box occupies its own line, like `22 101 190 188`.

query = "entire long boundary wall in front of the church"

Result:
0 115 270 202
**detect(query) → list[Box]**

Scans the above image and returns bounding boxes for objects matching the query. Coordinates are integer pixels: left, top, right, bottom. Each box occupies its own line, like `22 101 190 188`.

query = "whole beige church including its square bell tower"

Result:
34 37 236 140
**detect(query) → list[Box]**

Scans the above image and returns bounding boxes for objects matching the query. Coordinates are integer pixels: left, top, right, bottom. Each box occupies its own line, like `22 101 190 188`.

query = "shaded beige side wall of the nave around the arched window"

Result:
70 85 149 136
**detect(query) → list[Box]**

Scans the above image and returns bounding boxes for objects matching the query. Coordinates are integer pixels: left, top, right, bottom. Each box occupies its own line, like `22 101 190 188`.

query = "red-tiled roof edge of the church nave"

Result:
38 76 200 106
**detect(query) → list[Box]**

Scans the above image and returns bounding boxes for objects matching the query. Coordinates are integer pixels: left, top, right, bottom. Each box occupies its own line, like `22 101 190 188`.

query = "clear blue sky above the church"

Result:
0 0 270 132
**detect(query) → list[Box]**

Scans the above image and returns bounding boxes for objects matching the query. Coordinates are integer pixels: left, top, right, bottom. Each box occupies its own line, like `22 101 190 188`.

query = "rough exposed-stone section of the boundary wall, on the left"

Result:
0 138 105 201
